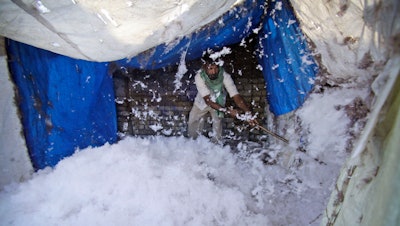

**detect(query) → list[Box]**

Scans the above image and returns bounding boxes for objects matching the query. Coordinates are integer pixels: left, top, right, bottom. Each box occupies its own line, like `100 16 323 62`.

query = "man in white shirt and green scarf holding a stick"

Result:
188 54 258 142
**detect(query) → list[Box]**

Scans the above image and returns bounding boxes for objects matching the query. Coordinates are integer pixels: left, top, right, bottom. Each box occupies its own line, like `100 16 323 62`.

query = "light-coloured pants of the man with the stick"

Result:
188 104 222 141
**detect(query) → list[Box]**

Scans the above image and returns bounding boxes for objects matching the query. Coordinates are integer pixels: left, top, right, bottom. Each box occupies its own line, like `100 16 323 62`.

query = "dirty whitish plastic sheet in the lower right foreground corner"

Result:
321 56 400 225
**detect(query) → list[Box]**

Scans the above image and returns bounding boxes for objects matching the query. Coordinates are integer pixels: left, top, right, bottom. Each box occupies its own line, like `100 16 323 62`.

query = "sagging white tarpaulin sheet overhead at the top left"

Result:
0 0 243 62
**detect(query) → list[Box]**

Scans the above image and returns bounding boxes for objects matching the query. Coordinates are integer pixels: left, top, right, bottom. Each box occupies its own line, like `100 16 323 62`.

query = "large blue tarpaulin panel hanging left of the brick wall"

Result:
6 40 117 170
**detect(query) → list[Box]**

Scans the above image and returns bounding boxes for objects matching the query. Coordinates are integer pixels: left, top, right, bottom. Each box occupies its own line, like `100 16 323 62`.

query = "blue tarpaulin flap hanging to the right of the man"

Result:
260 0 318 115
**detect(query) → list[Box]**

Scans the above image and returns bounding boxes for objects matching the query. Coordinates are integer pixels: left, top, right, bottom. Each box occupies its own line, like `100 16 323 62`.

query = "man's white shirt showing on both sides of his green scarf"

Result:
194 70 239 110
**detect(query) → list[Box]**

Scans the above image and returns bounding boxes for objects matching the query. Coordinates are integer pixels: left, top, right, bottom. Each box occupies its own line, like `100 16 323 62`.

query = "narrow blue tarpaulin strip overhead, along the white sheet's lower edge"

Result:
117 0 265 70
